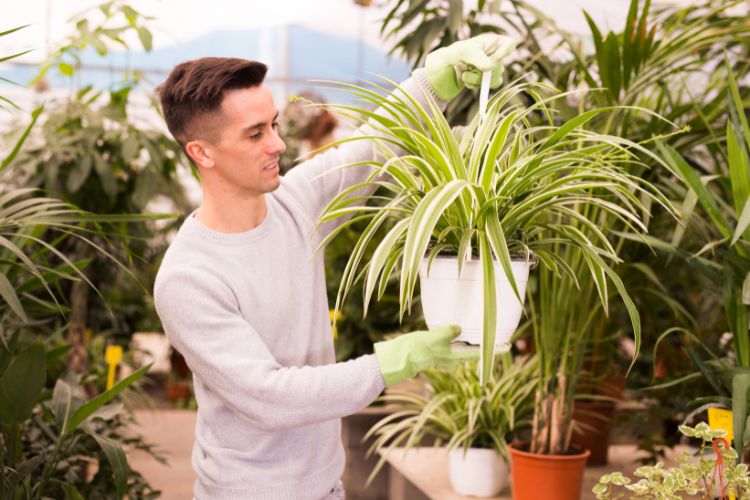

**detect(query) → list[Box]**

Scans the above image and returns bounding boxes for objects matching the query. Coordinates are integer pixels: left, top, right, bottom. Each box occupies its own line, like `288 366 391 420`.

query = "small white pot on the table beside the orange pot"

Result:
448 448 510 497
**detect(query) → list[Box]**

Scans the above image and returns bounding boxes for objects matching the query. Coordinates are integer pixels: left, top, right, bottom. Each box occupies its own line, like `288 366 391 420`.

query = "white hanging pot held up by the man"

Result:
419 257 531 352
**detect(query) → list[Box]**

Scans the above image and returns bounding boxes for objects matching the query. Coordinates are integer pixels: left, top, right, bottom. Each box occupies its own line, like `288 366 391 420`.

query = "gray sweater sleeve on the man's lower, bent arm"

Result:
154 270 384 431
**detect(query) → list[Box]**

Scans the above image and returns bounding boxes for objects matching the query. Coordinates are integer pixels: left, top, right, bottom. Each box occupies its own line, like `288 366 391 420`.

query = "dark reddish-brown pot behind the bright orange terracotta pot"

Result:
571 400 615 465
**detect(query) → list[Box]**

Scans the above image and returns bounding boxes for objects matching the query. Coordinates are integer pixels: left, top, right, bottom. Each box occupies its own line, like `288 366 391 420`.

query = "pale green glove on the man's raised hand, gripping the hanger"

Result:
424 33 516 101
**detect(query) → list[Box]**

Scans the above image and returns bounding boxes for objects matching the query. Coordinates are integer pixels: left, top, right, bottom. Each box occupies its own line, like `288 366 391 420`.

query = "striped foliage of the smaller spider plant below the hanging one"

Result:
365 353 537 481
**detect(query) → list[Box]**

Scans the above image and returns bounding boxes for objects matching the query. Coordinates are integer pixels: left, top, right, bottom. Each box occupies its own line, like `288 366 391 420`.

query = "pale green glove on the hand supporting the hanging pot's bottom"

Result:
375 326 479 387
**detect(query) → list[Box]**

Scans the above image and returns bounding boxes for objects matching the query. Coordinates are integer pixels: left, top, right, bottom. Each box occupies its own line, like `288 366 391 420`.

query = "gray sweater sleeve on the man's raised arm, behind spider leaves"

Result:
284 69 445 229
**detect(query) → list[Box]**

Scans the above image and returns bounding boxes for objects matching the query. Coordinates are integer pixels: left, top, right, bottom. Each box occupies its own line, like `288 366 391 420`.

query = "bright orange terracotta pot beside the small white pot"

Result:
509 443 589 500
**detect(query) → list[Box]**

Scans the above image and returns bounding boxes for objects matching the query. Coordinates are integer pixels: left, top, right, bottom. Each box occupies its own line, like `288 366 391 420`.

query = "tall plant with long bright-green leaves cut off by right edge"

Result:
624 61 750 456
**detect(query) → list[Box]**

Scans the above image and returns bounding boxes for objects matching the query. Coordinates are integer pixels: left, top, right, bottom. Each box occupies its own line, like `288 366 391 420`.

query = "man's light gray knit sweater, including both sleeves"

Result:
154 71 437 500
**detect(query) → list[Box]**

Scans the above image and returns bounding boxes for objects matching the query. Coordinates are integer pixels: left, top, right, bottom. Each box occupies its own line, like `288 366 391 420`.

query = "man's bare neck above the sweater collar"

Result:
195 191 268 233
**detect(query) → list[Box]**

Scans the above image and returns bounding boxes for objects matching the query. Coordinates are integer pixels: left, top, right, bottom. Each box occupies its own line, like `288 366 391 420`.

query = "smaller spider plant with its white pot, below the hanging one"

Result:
365 354 537 497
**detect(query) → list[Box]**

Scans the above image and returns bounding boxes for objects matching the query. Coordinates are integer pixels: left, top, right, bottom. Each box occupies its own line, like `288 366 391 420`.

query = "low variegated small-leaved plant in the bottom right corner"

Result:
593 422 750 500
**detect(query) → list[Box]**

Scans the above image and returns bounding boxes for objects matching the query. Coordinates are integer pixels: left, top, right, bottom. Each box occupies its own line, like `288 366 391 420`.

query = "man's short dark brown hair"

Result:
156 57 268 148
